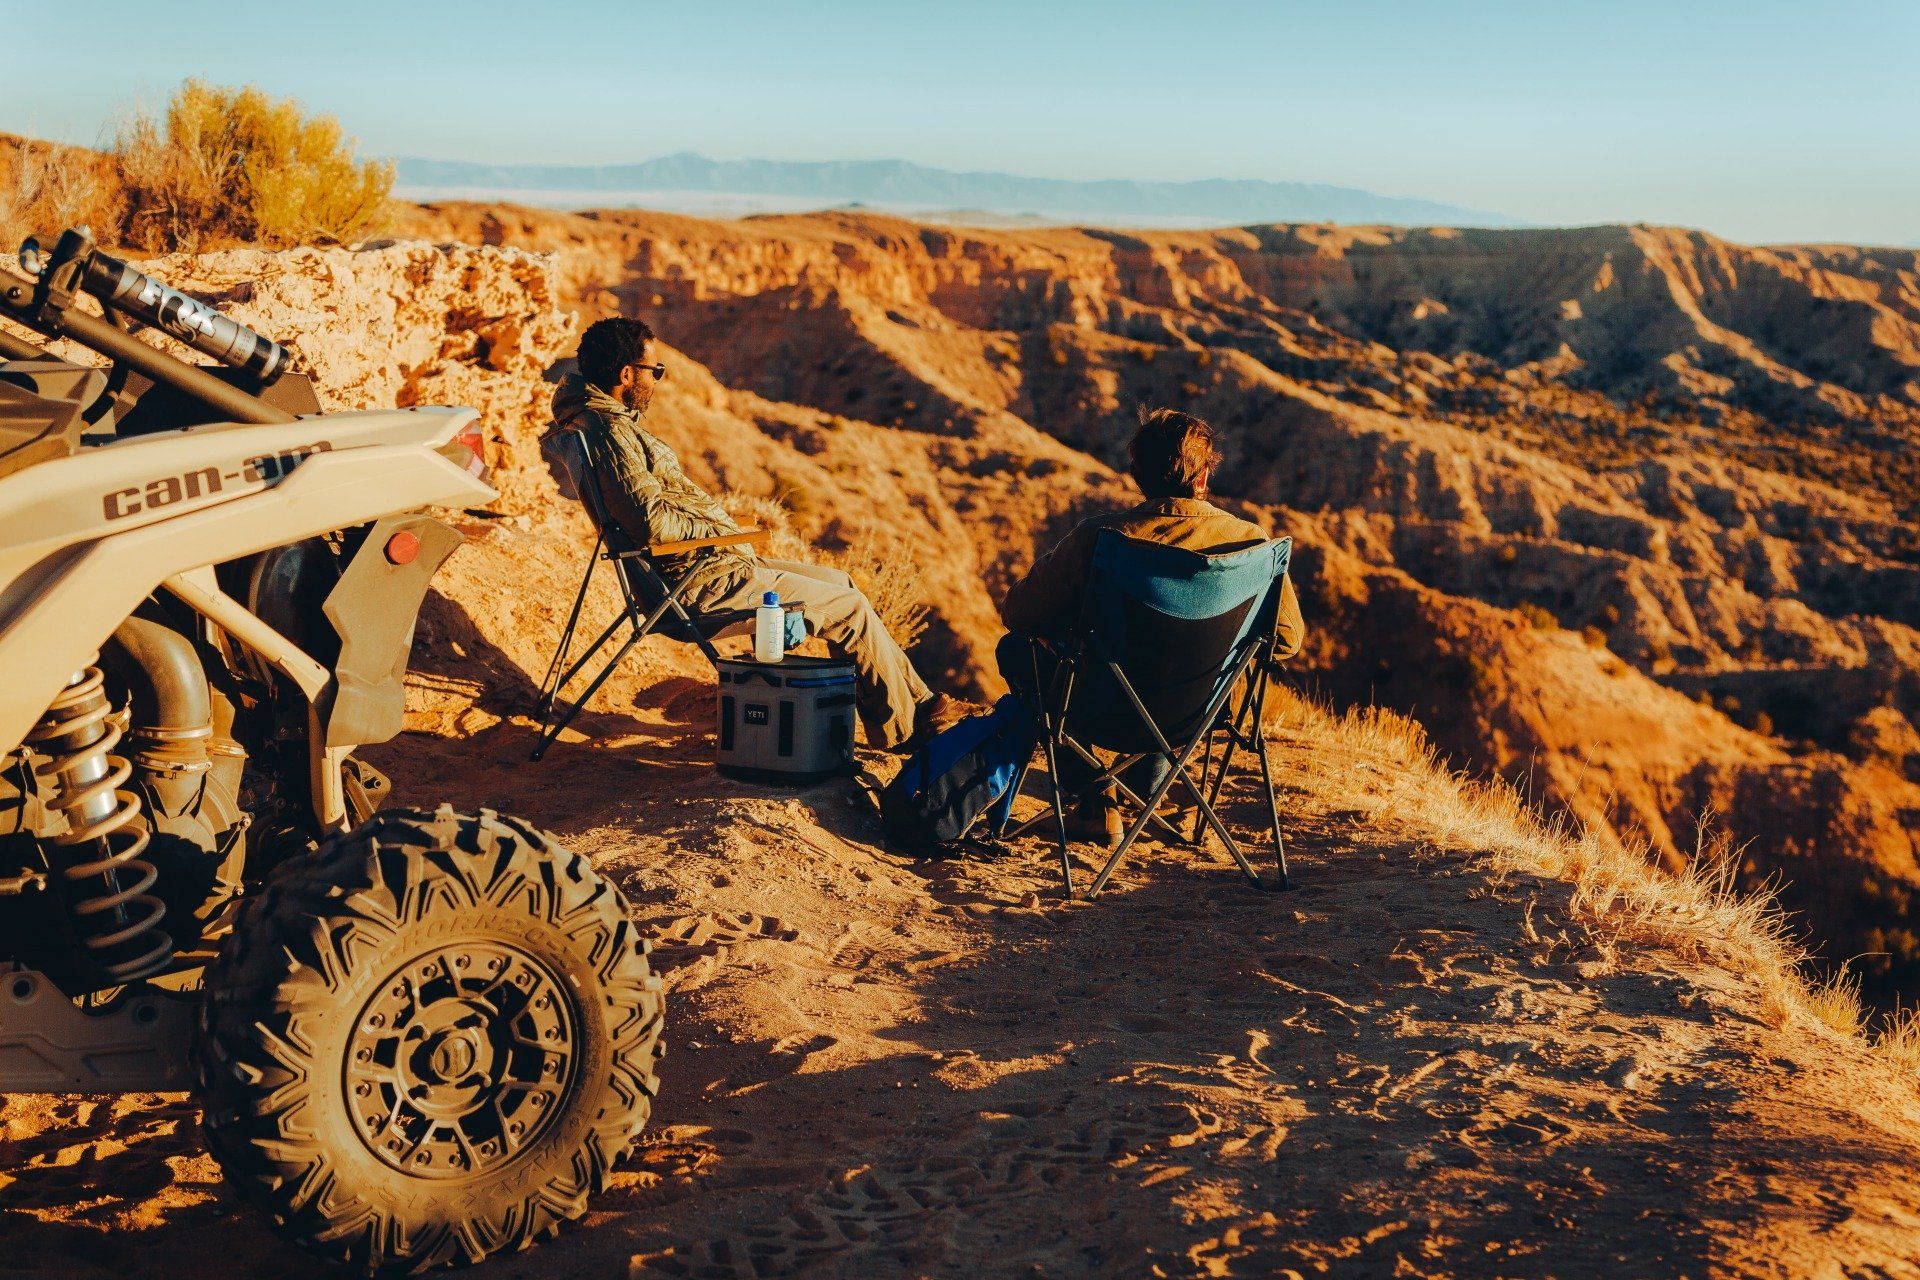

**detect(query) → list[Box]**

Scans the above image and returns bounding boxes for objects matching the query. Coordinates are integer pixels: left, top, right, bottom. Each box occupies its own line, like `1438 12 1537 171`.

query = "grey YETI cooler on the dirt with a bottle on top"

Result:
714 656 854 783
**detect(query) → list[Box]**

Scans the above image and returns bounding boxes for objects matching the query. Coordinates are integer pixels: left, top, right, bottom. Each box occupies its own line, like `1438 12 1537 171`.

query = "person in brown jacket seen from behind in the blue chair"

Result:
998 409 1306 844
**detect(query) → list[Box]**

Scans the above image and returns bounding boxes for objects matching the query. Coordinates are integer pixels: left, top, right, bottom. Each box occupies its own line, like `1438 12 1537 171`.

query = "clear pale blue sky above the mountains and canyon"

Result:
0 0 1920 246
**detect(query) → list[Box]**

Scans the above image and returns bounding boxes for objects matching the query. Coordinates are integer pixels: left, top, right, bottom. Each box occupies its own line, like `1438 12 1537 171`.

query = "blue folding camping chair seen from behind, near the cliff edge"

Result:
1006 532 1294 898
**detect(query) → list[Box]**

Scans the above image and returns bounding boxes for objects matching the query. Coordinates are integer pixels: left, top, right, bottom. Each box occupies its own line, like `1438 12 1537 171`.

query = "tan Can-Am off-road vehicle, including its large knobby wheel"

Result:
0 232 660 1272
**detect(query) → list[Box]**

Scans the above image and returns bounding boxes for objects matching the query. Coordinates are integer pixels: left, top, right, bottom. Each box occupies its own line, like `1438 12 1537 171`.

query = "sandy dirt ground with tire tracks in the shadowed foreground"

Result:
0 702 1920 1280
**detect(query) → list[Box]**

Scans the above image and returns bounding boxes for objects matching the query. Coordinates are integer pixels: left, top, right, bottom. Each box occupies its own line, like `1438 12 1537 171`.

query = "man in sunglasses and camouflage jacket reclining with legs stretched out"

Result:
541 317 958 748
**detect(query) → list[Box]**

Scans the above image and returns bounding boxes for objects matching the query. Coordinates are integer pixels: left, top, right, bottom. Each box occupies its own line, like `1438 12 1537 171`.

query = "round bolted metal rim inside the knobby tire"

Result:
346 942 578 1178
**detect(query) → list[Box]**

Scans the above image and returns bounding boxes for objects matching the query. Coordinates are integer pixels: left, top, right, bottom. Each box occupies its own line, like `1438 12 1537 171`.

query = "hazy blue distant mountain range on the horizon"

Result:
396 152 1524 226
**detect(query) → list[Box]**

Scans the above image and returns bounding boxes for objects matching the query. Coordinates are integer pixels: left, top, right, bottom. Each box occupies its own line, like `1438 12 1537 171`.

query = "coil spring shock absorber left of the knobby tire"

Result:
27 666 173 983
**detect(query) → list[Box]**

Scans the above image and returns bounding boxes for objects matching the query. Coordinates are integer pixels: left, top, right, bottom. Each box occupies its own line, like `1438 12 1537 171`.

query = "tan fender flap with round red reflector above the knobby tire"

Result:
321 514 465 747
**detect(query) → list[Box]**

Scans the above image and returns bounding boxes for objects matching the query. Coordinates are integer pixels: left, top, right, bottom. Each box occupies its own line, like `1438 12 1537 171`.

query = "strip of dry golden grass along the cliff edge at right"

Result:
1271 695 1889 1071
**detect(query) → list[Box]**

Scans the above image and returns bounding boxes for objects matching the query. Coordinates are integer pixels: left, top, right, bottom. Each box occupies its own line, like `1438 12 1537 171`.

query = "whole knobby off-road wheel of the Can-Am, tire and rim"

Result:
196 808 660 1274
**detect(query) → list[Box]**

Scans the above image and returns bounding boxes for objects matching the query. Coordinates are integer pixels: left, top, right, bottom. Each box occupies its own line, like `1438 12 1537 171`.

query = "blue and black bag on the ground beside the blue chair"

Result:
879 695 1039 858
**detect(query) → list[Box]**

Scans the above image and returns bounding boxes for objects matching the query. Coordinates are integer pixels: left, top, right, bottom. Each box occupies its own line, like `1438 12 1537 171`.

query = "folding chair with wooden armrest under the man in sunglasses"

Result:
534 435 806 760
